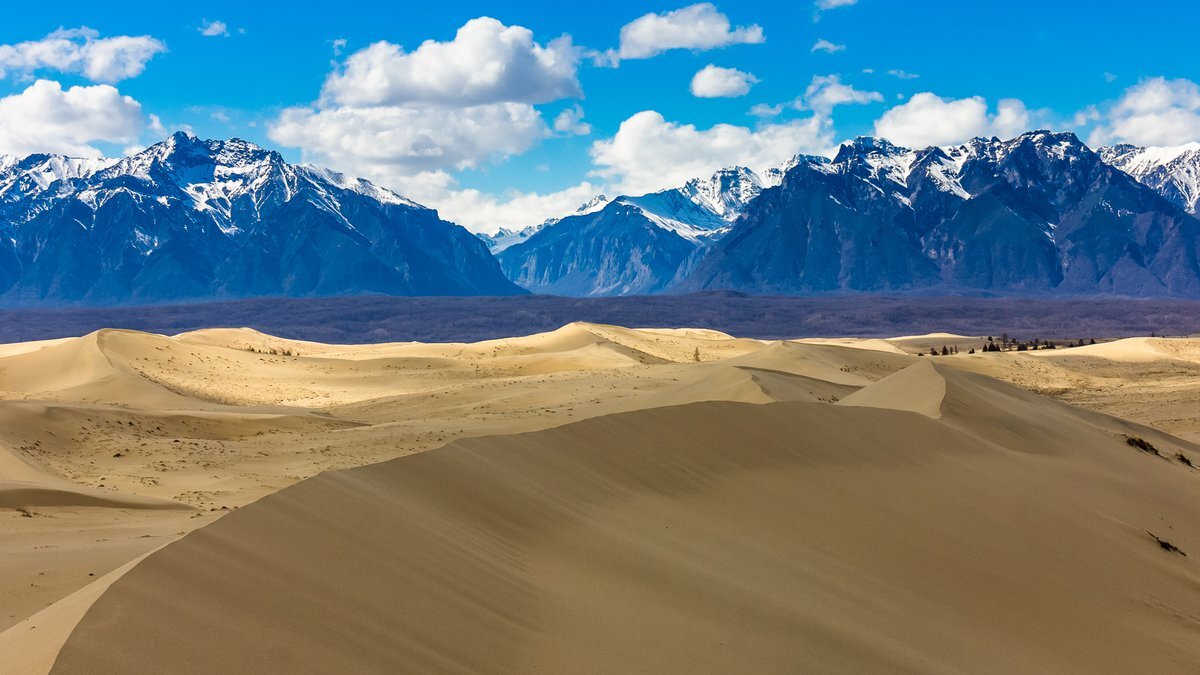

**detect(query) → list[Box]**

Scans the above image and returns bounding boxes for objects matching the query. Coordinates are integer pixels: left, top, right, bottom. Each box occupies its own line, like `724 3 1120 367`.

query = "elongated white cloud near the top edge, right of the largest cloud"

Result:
610 2 766 59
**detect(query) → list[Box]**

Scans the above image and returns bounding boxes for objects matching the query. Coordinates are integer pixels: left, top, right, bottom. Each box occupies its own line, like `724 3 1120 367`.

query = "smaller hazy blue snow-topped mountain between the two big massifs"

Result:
497 167 775 295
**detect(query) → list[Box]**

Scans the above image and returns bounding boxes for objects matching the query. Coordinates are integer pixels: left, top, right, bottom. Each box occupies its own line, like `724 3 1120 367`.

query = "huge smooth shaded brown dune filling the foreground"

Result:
55 363 1200 673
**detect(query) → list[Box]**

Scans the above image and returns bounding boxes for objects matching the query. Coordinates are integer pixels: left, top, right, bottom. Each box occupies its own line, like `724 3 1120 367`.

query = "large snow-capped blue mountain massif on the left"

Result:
0 133 520 304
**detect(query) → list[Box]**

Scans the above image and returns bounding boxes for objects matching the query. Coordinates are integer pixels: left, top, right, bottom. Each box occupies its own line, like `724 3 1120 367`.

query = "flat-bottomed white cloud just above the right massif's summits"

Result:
875 91 1030 148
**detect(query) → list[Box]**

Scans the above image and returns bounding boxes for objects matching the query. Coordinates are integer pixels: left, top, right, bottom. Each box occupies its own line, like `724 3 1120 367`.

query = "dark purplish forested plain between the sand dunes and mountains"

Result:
0 293 1200 341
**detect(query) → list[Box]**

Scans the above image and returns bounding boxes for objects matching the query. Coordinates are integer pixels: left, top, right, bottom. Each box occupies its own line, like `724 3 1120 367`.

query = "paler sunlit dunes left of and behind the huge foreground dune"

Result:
0 323 873 629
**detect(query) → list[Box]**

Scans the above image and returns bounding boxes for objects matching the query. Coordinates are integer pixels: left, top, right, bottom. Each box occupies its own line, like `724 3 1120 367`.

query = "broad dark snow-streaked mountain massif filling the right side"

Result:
672 131 1200 297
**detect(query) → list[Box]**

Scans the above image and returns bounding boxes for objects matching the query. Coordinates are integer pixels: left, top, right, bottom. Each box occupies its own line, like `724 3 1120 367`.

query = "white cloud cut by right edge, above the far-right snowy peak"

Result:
1088 77 1200 147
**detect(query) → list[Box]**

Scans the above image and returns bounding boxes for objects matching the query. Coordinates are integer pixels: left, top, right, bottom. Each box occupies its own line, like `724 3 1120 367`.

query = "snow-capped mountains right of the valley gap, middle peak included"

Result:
499 131 1200 297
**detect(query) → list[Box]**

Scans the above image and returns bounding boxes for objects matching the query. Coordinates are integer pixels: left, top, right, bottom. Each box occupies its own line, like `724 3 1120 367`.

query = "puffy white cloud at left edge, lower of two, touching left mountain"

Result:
0 79 145 157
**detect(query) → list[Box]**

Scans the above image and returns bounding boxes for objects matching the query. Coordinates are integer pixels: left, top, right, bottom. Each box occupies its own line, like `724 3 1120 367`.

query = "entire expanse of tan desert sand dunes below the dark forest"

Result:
0 324 1200 673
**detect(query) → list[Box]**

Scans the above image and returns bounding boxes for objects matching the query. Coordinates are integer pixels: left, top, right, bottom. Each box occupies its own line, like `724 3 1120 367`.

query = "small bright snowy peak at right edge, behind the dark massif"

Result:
1097 143 1200 215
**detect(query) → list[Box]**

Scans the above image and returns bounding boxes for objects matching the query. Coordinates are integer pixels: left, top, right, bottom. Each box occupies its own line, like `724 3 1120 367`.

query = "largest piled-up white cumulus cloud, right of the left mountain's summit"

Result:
268 17 592 229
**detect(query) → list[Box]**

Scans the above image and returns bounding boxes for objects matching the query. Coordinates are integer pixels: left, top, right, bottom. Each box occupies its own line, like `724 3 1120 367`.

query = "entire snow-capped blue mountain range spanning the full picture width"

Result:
0 131 1200 305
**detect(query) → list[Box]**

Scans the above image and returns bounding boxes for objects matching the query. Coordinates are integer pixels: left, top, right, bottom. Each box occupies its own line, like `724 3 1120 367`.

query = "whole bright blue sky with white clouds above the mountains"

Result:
7 0 1200 232
